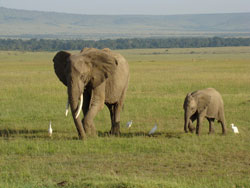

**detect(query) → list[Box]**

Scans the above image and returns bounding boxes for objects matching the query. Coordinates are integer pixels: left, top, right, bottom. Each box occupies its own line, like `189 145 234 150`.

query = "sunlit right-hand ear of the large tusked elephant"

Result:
85 50 118 88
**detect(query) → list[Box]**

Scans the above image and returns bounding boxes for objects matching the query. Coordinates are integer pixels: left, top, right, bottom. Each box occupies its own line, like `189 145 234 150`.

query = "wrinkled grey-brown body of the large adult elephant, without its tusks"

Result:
53 48 129 139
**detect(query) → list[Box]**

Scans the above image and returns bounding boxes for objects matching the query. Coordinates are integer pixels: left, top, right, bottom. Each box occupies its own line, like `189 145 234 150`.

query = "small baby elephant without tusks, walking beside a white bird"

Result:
183 88 226 135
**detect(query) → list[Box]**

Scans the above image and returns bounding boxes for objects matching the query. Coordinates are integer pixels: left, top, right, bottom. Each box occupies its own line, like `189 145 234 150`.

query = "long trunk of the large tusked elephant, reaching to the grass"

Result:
68 82 86 139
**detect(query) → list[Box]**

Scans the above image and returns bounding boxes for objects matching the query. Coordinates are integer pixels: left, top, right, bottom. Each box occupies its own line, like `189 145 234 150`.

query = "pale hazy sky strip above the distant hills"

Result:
0 0 250 15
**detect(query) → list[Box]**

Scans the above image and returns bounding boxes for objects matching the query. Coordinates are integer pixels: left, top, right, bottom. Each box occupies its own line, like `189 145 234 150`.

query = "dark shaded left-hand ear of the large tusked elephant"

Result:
53 51 71 86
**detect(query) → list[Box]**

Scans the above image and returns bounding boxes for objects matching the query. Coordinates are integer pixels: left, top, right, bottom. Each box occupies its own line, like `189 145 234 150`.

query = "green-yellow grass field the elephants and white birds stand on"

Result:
0 47 250 188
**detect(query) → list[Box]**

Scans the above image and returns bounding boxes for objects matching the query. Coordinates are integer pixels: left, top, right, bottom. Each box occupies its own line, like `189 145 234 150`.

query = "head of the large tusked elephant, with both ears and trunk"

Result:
53 49 117 139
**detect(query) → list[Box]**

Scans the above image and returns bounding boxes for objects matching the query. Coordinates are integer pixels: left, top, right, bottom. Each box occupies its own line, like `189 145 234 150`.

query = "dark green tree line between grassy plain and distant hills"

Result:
0 37 250 51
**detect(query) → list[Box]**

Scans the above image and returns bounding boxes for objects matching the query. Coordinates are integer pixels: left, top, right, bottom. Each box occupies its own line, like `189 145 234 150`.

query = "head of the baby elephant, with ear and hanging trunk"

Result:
183 92 211 132
